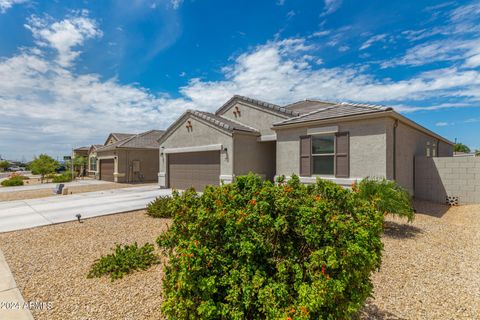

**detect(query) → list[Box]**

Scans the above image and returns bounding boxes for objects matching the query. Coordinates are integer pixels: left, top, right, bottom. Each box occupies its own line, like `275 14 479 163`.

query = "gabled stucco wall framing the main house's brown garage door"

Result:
157 116 233 187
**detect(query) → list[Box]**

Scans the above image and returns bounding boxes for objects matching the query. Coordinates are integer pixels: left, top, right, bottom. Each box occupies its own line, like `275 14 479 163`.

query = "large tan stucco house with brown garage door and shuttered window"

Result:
158 96 453 192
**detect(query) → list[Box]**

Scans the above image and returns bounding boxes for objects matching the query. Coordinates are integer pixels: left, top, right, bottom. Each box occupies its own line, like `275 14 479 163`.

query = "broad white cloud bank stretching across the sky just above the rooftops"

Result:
0 8 480 157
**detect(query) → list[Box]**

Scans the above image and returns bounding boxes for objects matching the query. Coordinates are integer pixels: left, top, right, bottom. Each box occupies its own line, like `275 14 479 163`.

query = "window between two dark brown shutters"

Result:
312 134 335 175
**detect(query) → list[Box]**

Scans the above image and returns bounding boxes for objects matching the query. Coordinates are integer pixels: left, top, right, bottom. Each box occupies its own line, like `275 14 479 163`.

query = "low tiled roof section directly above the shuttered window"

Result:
273 102 393 127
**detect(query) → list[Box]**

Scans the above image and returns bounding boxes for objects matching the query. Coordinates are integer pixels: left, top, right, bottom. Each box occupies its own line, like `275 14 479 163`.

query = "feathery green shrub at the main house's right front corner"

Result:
352 178 415 222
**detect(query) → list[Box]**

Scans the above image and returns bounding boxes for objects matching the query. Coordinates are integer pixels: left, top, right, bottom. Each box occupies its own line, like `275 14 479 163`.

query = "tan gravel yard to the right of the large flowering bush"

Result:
362 201 480 319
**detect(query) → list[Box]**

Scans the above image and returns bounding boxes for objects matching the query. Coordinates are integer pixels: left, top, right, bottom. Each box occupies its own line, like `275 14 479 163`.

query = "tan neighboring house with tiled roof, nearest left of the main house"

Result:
94 130 163 183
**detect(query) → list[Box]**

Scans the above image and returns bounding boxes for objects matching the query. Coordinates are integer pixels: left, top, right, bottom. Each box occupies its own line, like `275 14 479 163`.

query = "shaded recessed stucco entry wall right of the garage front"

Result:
233 134 276 180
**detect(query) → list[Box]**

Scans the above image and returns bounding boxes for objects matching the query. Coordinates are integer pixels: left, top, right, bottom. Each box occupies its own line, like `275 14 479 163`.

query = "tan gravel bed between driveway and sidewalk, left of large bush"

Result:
0 211 168 320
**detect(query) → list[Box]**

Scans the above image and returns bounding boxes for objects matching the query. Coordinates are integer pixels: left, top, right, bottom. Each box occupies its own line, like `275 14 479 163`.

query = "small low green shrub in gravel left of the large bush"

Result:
87 242 160 281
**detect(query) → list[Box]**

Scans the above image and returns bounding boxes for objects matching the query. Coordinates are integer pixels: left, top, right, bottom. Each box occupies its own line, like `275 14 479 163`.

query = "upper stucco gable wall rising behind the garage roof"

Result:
220 102 286 135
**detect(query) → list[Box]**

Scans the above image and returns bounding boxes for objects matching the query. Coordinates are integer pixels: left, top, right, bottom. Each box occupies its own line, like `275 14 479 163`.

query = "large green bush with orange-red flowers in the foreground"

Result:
157 175 383 319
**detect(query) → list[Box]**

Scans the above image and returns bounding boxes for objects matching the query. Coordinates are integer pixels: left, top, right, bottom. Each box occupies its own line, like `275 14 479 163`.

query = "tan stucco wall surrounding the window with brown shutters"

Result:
277 119 387 178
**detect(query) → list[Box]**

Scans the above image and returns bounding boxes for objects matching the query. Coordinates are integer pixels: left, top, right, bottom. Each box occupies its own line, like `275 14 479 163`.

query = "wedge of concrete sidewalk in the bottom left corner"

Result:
0 250 33 320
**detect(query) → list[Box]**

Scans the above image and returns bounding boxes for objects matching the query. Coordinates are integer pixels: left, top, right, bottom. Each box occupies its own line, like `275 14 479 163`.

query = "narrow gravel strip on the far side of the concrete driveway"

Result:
0 182 148 201
